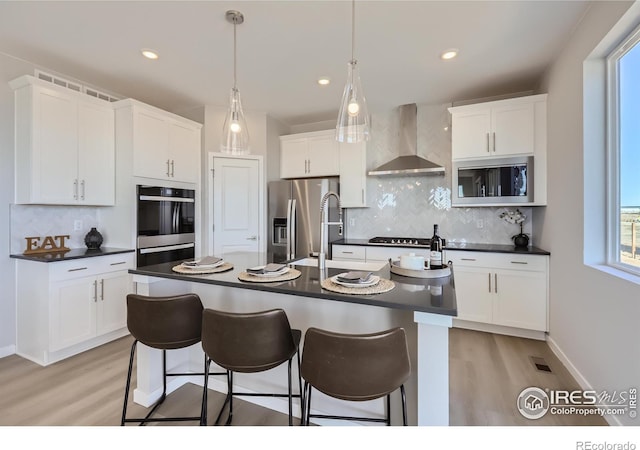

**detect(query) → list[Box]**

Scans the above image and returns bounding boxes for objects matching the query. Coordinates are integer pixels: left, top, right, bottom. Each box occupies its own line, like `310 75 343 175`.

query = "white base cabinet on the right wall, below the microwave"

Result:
447 250 549 332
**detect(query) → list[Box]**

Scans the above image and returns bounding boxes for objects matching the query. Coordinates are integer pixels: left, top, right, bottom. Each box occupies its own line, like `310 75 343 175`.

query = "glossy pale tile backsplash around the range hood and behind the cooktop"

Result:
345 104 533 244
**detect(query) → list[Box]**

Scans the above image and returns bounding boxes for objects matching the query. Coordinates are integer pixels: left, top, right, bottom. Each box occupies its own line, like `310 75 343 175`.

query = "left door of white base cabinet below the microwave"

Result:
454 266 494 323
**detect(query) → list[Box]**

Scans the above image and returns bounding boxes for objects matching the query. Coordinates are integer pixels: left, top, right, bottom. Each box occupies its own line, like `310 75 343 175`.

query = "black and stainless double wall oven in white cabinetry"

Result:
137 185 195 267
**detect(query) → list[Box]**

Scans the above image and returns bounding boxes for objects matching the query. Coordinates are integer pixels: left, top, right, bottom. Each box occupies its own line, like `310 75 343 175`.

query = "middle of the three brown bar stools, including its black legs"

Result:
202 309 304 425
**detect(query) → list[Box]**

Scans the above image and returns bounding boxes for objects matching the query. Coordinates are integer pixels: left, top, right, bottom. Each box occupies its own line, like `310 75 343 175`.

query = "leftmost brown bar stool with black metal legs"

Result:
120 294 226 425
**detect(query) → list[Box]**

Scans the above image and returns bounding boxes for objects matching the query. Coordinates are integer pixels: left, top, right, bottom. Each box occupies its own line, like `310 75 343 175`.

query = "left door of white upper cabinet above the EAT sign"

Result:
34 88 78 204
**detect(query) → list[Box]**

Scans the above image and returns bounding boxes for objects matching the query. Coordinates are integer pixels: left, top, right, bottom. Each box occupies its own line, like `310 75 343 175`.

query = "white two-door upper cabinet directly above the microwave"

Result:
449 94 546 160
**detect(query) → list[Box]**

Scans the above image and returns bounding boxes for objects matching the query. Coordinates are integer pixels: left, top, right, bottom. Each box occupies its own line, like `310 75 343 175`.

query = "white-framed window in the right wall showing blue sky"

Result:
607 29 640 274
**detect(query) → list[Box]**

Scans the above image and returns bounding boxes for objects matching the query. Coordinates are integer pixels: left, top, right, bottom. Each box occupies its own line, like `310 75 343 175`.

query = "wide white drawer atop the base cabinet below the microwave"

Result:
445 250 548 271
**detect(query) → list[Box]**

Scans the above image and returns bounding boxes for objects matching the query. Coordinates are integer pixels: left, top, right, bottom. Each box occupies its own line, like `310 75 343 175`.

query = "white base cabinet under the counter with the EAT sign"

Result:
16 253 134 365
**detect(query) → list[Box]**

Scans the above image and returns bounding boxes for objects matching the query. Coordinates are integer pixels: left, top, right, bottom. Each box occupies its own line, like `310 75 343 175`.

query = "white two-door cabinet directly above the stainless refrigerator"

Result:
280 130 340 178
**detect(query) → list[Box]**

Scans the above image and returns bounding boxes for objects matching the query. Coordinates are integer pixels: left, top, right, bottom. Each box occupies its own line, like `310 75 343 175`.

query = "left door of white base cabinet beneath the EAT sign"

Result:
49 277 98 351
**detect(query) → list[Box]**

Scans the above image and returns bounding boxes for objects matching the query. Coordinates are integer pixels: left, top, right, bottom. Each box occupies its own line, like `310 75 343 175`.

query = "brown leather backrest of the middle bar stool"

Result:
202 309 297 373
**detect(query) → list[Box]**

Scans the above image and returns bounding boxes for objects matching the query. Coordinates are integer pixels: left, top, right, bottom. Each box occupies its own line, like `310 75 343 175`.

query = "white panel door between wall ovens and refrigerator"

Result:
213 157 261 257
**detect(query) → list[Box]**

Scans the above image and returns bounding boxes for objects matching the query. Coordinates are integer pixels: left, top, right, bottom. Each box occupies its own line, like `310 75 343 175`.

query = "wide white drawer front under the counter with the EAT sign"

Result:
47 253 135 281
